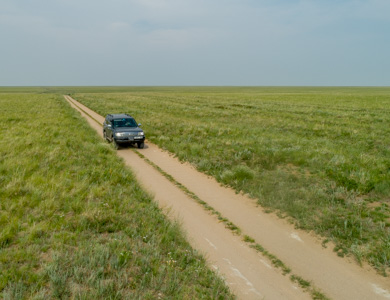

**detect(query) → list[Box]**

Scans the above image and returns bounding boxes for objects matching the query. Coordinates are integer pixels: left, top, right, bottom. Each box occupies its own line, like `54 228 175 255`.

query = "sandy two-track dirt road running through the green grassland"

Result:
65 96 390 299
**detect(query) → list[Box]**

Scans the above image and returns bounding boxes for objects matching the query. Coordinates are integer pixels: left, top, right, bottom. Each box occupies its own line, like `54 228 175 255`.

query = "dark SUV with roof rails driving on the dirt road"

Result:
103 114 145 149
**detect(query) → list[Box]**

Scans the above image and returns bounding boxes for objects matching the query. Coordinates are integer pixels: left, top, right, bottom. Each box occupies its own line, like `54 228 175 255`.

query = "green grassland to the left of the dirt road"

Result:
0 92 233 299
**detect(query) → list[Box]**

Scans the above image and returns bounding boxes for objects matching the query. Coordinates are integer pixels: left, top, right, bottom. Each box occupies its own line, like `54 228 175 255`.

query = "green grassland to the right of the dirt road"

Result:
68 87 390 274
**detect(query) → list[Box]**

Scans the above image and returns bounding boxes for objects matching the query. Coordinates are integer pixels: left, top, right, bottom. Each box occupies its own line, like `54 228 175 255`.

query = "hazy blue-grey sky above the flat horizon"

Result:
0 0 390 86
